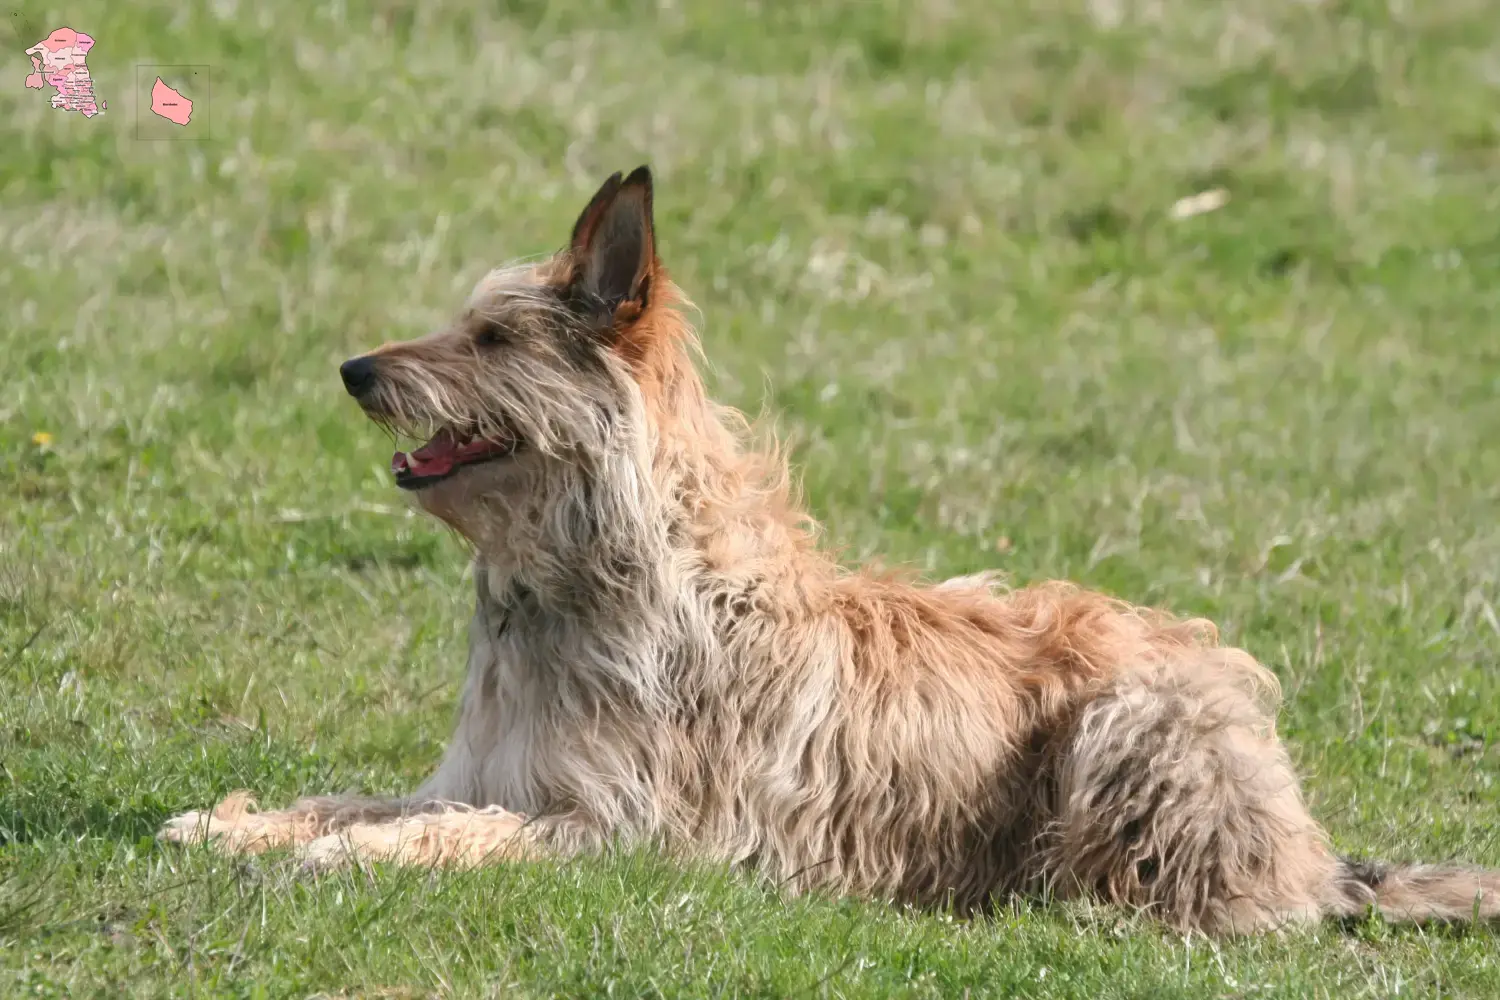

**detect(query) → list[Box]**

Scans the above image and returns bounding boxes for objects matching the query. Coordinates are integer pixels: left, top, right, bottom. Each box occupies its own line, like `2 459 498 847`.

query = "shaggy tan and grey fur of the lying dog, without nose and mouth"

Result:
164 169 1500 933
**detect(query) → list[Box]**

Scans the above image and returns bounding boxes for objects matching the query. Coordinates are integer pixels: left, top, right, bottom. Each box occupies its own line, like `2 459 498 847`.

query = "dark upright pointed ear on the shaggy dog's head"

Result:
572 166 656 316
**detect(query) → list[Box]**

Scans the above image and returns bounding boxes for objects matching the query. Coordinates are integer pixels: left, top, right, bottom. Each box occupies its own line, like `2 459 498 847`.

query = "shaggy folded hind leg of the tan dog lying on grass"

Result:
1044 649 1338 934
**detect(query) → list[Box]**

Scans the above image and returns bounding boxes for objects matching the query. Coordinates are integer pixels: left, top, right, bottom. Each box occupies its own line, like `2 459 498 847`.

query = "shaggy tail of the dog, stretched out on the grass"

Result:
1329 858 1500 924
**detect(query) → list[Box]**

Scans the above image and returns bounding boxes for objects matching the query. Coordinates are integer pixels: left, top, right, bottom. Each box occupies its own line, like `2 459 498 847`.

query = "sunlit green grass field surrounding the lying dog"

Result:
0 0 1500 999
